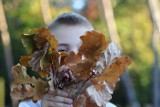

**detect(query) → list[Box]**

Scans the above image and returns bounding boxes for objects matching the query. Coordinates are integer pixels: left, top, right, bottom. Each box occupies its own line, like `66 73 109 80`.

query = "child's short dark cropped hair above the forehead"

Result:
48 12 93 30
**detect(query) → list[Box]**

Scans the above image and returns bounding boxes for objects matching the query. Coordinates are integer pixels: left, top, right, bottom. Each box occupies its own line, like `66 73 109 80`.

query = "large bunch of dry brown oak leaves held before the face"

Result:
10 28 131 107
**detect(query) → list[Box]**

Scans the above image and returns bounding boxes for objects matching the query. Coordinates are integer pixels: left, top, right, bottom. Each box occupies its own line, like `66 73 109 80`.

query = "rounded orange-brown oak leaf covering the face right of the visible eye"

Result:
79 30 109 61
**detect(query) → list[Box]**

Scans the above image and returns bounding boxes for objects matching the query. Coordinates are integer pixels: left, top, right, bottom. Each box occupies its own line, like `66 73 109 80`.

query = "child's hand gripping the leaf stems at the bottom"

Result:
41 90 73 107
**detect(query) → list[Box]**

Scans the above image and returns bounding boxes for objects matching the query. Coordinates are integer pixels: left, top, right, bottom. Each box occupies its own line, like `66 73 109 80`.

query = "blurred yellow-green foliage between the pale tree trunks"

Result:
0 0 160 107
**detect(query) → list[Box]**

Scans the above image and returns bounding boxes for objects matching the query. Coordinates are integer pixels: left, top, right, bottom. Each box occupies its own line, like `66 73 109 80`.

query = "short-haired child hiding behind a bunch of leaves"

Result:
19 13 115 107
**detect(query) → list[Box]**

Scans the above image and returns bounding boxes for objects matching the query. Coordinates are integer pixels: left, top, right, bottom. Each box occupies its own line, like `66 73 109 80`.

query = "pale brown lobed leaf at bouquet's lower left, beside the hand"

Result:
11 64 48 100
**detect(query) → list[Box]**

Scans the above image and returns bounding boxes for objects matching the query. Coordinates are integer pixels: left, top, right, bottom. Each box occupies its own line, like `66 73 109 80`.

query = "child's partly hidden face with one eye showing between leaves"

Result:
51 25 91 52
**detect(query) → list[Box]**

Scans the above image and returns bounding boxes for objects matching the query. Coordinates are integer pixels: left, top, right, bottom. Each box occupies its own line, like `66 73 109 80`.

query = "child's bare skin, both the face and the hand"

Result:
41 25 92 107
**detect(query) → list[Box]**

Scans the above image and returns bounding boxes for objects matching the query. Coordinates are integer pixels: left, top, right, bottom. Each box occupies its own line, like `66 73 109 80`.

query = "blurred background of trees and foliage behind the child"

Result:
0 0 160 107
